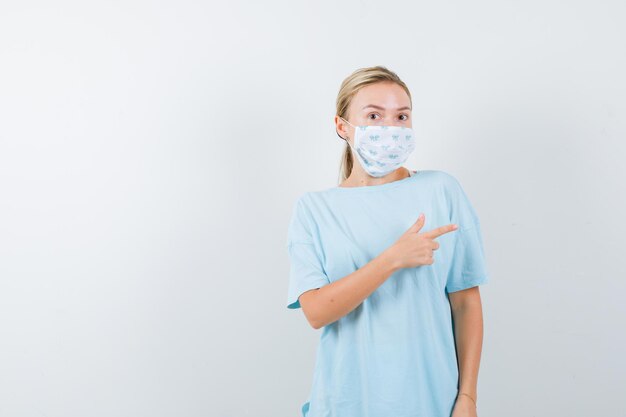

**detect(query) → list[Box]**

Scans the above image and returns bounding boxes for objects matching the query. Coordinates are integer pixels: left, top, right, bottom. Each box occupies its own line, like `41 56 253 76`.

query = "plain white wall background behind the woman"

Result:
0 0 626 417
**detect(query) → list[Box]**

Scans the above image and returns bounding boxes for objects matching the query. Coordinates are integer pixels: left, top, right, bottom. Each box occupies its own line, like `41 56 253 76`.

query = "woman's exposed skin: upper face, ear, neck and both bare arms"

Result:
299 82 483 417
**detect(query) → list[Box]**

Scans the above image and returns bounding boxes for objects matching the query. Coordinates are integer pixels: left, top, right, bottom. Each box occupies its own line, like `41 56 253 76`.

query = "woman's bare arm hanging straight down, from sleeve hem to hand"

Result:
448 286 483 417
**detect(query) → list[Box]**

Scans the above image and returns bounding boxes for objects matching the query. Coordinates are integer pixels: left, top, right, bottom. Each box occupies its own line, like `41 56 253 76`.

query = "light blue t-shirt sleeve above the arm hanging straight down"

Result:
446 174 489 293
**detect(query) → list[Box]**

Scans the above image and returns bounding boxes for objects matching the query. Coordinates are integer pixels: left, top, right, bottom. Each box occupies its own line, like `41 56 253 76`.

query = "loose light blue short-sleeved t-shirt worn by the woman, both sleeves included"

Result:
287 170 488 417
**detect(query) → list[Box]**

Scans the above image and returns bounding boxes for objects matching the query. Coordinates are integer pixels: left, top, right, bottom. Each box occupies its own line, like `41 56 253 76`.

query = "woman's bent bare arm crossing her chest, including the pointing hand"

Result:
299 215 457 329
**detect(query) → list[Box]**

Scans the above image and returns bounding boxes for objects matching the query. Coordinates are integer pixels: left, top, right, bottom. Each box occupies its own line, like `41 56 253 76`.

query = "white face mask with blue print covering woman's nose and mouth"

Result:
340 116 415 177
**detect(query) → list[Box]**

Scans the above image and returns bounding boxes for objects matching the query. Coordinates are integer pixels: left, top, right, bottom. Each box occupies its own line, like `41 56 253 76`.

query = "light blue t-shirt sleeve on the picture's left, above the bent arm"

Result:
287 196 330 309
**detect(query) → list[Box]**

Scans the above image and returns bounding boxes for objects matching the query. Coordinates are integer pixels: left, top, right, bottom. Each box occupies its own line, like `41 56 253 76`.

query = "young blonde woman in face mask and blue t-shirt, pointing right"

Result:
287 66 488 417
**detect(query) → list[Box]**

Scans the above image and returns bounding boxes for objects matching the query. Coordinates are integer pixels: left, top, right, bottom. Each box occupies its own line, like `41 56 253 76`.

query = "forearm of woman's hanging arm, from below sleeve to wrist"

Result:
452 297 483 401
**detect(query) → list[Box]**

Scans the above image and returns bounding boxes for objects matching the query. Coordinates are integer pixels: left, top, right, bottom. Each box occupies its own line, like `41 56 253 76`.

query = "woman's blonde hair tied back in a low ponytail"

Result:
337 65 413 182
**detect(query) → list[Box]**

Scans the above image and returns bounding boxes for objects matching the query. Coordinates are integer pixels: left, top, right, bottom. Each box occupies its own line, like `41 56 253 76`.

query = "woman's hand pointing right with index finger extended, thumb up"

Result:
387 213 458 269
